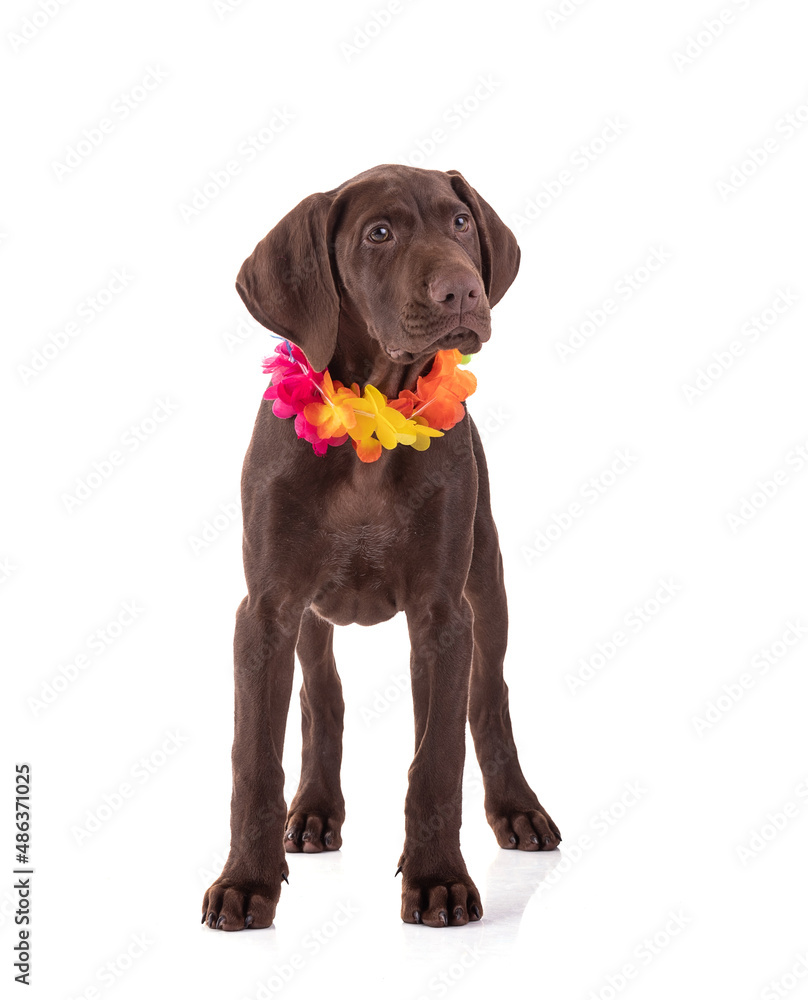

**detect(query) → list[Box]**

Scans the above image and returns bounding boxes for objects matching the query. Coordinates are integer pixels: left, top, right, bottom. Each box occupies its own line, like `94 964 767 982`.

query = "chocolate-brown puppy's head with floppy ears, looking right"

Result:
236 165 519 371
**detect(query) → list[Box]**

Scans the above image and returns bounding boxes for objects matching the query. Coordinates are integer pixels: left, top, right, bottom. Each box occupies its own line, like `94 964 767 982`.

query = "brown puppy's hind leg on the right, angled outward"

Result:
465 423 561 851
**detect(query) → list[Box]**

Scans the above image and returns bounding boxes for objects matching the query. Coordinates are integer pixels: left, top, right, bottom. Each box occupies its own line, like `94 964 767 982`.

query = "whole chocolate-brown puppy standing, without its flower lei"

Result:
202 165 561 930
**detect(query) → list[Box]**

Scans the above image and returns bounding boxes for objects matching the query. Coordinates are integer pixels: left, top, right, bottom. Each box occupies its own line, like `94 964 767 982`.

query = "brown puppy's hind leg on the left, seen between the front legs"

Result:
284 609 345 854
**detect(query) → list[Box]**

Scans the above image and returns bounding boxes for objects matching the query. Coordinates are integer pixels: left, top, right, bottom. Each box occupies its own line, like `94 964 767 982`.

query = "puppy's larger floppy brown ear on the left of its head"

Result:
236 194 339 371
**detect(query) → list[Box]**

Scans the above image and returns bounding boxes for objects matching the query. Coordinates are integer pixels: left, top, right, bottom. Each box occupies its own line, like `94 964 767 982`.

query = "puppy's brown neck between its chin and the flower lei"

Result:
328 313 434 399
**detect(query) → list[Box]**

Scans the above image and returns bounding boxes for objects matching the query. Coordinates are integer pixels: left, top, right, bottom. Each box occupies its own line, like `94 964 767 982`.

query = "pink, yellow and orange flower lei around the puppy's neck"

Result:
264 340 477 462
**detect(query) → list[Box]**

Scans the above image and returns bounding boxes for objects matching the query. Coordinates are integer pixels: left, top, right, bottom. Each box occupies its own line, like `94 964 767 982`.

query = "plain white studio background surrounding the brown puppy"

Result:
0 0 808 1000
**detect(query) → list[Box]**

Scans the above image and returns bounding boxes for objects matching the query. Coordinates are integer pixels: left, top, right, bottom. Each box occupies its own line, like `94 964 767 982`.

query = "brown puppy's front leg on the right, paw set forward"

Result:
399 597 483 927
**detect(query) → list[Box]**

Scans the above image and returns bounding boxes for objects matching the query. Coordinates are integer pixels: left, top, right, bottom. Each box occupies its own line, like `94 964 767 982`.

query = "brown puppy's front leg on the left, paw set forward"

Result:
202 598 301 931
